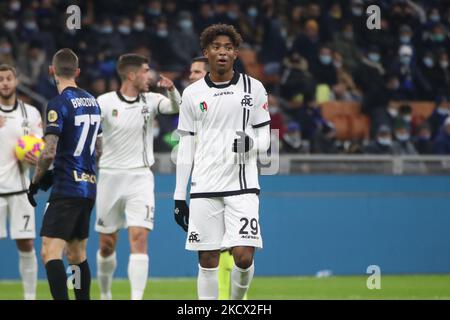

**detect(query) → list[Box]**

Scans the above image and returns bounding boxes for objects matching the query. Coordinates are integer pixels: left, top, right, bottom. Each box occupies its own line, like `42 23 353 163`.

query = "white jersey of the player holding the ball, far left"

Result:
0 100 43 195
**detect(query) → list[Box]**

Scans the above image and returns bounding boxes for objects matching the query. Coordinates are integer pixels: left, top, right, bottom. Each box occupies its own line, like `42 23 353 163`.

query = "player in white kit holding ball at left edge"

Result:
0 64 43 300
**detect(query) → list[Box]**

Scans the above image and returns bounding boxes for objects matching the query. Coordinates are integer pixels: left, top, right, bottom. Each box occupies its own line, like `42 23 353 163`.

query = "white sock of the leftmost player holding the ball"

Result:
19 249 37 300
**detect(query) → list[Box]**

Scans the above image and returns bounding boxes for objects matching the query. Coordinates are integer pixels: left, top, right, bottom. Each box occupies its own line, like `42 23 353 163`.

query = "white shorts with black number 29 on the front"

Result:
186 194 262 251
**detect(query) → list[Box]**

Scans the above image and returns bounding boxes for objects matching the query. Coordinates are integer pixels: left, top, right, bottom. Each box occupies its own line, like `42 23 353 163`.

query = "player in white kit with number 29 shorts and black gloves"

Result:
174 24 270 300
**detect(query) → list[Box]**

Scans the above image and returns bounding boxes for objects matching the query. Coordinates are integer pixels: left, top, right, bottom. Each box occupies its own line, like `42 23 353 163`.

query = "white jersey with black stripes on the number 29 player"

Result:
177 72 270 198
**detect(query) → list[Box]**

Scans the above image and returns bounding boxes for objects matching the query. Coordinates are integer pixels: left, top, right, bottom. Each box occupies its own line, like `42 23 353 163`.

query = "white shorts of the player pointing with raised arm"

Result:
95 168 155 233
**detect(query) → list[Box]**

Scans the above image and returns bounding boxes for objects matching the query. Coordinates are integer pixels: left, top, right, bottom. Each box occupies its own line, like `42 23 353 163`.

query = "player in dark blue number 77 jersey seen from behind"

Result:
28 48 102 300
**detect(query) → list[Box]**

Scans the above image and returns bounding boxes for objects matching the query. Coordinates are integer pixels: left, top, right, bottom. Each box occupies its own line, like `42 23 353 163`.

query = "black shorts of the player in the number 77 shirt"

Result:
40 198 95 241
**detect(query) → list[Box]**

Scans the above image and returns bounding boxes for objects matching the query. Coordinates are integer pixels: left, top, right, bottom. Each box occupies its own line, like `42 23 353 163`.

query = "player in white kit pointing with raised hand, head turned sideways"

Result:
95 54 181 300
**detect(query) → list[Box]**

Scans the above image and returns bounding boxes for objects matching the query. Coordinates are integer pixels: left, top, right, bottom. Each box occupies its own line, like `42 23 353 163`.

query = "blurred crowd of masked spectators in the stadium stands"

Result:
0 0 450 154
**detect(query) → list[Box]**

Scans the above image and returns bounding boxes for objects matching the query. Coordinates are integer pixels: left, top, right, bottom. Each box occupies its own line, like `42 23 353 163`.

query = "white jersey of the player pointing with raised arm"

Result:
97 89 180 169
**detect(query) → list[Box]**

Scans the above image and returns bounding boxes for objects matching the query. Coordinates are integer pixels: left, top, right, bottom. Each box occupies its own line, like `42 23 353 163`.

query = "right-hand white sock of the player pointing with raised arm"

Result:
128 253 148 300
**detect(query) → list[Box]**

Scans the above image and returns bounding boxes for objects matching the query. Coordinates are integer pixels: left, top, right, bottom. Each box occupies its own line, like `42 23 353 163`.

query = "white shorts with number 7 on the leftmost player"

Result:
0 193 36 239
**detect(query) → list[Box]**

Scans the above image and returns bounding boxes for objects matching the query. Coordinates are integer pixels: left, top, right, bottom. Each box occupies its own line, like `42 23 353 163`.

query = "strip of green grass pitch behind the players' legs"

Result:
0 275 450 300
